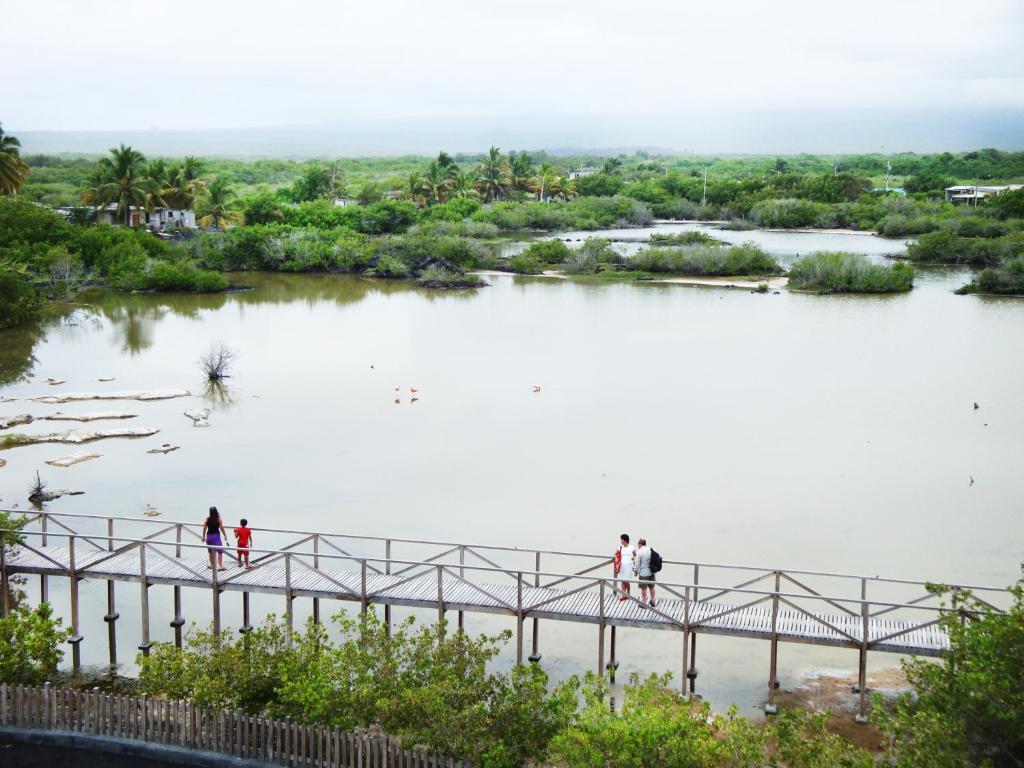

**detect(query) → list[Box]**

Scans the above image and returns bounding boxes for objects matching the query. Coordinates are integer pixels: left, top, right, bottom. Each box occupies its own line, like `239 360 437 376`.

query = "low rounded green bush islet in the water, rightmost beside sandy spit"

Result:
790 251 913 293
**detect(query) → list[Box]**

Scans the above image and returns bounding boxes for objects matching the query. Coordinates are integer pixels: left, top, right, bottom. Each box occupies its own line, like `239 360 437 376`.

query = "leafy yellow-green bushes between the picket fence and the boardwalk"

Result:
139 614 575 768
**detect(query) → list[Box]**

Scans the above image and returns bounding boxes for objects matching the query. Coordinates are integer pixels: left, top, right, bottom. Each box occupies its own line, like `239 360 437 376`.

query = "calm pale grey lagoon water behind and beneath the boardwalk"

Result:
0 232 1024 712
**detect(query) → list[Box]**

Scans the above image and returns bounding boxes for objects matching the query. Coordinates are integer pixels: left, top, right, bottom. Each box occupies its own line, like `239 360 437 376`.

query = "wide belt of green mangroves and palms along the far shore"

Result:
0 122 1024 327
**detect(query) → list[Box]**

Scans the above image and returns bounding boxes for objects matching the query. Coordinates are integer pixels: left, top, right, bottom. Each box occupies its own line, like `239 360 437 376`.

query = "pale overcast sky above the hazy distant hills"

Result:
6 0 1024 151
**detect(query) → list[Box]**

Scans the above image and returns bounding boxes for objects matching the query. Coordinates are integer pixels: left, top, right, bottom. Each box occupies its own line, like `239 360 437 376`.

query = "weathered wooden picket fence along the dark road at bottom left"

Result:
0 683 469 768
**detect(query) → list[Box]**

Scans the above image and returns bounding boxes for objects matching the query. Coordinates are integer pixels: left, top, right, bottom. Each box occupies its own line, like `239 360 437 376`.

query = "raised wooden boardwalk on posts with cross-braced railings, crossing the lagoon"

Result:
0 513 1009 718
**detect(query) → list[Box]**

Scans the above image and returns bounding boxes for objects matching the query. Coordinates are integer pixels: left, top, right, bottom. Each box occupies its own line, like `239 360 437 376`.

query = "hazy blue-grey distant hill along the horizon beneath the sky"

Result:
16 109 1024 158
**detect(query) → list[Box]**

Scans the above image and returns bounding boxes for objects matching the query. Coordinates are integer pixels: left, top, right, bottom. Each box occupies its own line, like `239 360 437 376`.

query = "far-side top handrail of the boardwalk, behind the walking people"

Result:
0 509 1006 593
